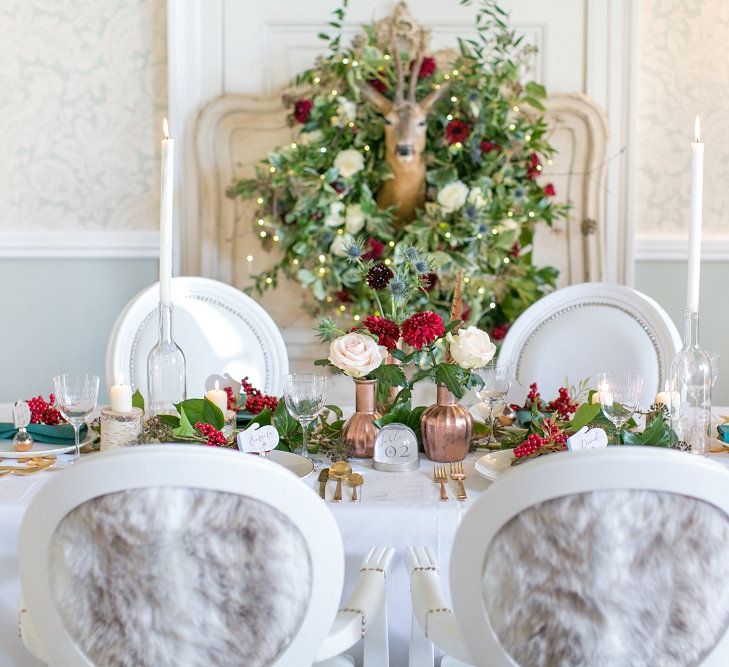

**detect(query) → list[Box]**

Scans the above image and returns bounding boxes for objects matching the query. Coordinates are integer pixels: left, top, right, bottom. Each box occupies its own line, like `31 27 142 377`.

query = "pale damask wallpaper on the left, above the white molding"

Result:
0 0 167 231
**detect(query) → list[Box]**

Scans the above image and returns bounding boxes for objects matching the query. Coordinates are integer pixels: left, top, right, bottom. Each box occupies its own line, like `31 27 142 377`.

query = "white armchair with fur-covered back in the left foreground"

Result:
19 445 394 667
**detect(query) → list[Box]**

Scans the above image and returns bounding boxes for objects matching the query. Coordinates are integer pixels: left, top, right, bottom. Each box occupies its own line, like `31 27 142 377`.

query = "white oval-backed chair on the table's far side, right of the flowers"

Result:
499 283 681 406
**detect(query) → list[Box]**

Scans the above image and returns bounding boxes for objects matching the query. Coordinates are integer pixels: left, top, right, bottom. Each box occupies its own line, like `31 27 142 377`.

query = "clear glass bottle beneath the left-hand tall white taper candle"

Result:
147 302 186 415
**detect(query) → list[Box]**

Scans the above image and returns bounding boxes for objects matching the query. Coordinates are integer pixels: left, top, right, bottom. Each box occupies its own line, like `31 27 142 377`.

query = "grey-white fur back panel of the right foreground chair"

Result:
483 490 729 667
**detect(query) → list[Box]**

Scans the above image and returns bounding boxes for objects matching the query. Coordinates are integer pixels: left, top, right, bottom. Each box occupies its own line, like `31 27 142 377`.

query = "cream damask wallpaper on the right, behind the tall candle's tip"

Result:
636 0 729 235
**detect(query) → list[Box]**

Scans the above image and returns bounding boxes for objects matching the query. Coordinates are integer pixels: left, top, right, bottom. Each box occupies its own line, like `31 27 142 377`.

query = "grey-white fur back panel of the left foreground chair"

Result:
50 487 311 667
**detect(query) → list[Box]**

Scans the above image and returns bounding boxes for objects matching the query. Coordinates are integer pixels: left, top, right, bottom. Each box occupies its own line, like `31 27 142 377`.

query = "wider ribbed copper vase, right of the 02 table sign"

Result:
420 384 473 463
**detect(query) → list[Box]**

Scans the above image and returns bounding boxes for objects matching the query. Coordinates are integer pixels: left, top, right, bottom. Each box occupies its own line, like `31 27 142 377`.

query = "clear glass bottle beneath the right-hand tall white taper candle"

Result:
669 308 711 456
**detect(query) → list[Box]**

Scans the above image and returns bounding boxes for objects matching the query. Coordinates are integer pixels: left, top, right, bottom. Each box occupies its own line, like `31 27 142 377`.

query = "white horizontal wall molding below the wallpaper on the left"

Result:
0 230 159 259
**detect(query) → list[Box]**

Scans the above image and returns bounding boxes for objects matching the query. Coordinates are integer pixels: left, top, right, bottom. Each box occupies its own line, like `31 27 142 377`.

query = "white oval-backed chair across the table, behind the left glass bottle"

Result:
106 277 289 397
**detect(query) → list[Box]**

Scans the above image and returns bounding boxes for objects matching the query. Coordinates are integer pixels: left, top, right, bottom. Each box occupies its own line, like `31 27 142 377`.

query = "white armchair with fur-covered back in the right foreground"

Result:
405 446 729 667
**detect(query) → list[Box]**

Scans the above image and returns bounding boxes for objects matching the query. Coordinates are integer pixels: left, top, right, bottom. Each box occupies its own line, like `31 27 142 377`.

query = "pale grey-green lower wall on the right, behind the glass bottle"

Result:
635 262 729 406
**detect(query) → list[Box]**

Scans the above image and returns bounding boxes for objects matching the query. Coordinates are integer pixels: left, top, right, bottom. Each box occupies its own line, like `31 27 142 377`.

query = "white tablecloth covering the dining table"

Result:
0 420 729 667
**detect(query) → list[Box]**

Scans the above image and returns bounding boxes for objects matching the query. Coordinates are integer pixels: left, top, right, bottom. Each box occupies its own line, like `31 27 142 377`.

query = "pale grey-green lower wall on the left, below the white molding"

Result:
0 259 157 402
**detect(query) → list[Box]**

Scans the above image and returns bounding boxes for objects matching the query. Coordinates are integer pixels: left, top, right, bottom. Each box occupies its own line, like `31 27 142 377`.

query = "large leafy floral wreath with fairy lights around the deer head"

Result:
229 0 566 340
